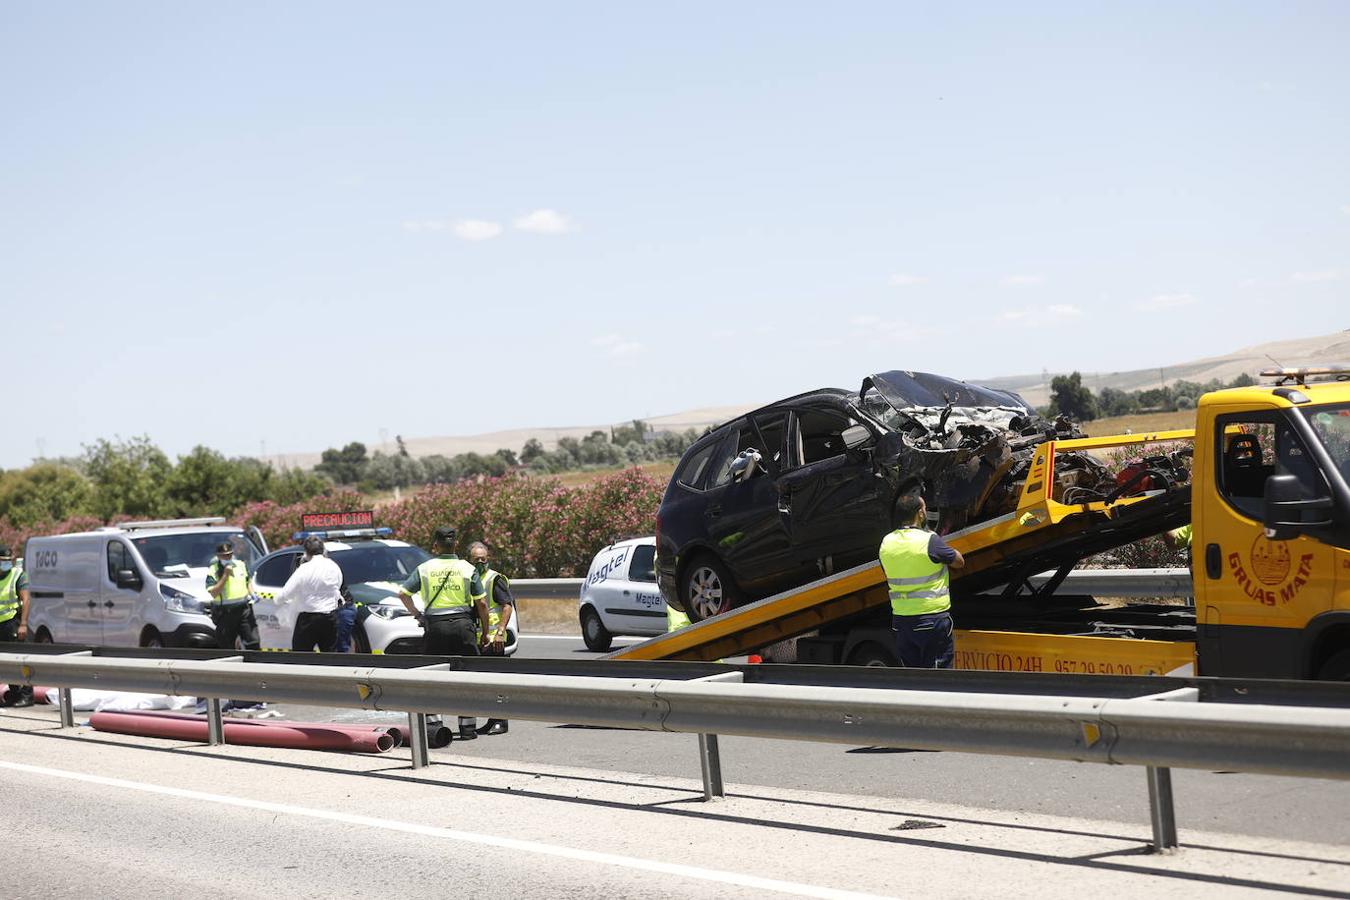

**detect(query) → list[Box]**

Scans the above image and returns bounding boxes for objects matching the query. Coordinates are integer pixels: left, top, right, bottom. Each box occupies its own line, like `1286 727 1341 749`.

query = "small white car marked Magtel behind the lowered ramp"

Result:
578 537 666 652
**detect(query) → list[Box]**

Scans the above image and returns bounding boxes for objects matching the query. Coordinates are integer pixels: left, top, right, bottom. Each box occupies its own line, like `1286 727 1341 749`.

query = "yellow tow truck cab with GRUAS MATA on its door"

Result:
1191 367 1350 680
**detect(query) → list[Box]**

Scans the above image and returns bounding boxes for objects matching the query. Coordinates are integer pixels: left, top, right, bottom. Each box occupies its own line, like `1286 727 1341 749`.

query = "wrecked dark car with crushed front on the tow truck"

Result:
656 371 1107 621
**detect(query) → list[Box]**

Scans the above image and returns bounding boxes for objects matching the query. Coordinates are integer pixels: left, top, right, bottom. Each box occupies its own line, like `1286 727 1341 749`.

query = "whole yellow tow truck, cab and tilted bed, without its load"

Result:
610 366 1350 680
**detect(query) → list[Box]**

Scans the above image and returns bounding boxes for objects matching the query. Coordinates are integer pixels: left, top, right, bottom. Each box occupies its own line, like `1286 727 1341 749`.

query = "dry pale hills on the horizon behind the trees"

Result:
269 331 1350 468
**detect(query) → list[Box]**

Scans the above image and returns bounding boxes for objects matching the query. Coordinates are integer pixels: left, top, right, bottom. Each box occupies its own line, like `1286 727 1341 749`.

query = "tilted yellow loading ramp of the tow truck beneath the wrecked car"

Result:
603 430 1195 660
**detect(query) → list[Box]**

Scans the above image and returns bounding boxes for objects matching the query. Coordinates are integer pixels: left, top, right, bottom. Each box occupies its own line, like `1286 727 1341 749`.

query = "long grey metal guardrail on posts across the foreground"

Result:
0 648 1350 849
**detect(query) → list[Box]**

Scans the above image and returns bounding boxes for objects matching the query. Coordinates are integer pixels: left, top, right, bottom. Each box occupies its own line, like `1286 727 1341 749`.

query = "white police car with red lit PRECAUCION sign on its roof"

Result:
245 528 520 656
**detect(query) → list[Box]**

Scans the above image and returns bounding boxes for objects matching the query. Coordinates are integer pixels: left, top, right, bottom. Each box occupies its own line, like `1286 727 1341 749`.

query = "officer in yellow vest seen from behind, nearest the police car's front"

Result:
398 525 487 739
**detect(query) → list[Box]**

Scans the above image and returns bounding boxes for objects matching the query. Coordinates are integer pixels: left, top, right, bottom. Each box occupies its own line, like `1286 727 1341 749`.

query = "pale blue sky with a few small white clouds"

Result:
0 1 1350 467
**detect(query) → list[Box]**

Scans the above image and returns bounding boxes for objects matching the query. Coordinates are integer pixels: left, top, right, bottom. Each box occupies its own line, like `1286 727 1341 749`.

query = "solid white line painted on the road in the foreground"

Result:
0 760 886 900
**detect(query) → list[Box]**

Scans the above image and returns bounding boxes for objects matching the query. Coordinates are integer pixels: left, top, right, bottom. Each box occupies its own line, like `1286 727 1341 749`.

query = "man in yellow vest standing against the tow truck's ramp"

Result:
879 493 965 669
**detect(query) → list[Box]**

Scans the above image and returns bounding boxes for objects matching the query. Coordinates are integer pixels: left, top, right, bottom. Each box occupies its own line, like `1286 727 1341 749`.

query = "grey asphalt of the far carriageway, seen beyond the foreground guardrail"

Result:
257 634 1350 846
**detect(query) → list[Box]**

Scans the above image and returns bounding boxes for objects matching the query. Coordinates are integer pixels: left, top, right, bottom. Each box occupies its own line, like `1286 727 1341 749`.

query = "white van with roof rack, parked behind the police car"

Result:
24 518 266 648
